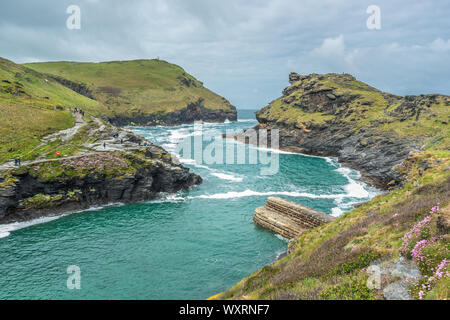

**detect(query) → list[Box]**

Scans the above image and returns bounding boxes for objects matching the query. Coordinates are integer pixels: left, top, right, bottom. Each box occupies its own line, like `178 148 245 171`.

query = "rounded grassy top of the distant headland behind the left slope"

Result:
26 60 236 116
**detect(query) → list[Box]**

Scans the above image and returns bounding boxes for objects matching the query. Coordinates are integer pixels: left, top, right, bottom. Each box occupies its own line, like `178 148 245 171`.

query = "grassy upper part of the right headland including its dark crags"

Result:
258 73 450 142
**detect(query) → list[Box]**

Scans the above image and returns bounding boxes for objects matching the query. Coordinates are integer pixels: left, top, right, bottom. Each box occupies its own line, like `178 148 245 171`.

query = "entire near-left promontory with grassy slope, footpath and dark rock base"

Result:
0 59 201 223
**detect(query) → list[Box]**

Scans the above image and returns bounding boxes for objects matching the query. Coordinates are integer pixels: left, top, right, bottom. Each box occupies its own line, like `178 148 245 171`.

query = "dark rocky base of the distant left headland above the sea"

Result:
108 99 237 126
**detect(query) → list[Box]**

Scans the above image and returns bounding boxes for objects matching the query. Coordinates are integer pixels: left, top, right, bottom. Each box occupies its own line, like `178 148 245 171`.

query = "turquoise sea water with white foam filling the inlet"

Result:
0 111 376 299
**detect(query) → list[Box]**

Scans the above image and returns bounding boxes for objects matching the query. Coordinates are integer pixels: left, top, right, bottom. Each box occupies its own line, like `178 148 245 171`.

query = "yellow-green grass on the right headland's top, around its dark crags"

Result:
259 74 450 141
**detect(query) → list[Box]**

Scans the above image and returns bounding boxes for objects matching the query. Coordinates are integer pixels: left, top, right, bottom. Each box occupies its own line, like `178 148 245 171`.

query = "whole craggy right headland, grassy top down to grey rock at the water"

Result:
257 73 450 188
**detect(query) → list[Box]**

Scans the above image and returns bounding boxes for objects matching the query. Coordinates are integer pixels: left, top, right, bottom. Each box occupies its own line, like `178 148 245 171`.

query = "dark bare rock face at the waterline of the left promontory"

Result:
0 163 202 223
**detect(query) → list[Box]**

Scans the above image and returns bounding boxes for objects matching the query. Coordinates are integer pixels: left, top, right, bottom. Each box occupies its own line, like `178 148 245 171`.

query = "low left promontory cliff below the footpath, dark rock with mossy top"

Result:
0 146 202 223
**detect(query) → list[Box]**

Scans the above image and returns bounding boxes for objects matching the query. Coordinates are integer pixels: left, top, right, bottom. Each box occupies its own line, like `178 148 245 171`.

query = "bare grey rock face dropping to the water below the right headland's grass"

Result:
250 118 414 188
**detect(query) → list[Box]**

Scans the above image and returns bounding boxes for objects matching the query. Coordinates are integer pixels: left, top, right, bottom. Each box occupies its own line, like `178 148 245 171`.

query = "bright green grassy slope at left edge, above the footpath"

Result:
0 58 99 163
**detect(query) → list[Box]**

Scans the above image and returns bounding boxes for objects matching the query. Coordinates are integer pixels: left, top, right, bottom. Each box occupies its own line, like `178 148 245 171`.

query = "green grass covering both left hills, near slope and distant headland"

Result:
0 58 231 164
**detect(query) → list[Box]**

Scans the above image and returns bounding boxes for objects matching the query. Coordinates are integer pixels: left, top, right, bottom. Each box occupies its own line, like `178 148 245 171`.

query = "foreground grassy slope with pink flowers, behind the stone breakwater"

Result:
216 152 450 299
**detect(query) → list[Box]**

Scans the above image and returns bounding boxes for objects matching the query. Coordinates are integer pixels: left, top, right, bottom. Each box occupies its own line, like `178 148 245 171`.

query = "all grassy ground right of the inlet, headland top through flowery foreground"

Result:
212 74 450 300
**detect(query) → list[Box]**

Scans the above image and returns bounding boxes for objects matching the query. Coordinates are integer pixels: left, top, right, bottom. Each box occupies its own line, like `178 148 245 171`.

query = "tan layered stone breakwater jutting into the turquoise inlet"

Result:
253 197 335 239
